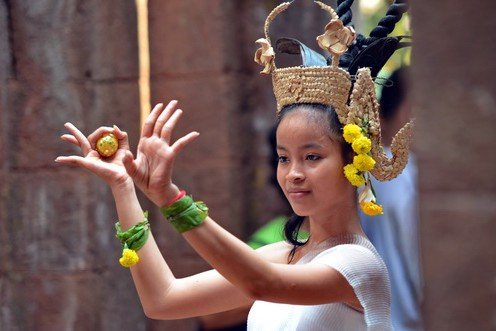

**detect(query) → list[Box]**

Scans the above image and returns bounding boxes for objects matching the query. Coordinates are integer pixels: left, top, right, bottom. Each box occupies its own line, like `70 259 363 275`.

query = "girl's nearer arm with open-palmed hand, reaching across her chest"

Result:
124 101 356 310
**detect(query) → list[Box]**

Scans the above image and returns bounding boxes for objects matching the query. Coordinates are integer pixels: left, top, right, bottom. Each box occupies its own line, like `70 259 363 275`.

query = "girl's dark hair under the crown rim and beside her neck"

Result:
276 103 353 262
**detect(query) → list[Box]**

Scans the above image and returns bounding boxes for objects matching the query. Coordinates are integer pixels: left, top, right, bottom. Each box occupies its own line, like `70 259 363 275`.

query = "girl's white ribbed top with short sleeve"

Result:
248 235 392 331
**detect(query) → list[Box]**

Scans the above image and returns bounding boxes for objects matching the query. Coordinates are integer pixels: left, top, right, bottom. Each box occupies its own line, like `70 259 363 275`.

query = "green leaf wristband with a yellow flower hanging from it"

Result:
115 211 150 268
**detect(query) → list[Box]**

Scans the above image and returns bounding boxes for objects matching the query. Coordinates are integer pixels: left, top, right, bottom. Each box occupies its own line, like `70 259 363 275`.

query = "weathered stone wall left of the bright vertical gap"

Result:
0 1 146 330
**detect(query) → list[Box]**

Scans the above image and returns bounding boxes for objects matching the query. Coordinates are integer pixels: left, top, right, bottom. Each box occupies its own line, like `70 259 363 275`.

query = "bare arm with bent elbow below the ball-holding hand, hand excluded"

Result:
112 183 252 319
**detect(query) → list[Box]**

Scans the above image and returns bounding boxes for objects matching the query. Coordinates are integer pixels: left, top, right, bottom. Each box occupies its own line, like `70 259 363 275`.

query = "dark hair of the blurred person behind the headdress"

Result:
380 67 409 121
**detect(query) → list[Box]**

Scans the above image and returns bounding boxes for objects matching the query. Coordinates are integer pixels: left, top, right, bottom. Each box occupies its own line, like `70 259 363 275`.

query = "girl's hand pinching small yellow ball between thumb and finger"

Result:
55 123 132 187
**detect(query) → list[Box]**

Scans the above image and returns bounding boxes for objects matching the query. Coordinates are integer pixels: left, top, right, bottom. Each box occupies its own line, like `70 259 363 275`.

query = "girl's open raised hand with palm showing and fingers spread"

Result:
123 100 199 207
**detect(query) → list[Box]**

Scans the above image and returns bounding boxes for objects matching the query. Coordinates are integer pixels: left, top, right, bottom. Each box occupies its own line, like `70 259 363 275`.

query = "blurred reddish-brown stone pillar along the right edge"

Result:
412 0 496 331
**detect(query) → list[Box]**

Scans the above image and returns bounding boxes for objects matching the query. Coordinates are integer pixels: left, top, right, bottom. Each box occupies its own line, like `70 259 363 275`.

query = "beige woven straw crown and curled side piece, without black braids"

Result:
255 1 413 185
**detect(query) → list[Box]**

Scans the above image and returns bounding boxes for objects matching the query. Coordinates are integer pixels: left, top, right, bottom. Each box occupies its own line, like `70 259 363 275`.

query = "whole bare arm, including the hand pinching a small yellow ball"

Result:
56 123 252 319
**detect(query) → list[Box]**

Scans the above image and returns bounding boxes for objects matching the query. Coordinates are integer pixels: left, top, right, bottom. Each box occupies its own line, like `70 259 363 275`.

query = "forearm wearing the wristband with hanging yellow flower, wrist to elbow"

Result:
112 182 175 315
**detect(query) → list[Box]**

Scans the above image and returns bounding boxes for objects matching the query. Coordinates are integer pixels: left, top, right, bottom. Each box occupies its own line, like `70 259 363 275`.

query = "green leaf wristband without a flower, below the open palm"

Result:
160 195 208 233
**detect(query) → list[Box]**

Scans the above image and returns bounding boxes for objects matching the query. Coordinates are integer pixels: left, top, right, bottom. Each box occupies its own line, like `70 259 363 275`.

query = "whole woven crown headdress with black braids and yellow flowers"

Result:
255 0 413 217
